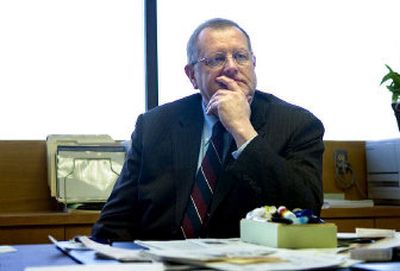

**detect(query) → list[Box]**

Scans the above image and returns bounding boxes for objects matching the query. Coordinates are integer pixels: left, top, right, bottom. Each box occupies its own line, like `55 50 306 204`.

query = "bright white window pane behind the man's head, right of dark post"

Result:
158 0 400 140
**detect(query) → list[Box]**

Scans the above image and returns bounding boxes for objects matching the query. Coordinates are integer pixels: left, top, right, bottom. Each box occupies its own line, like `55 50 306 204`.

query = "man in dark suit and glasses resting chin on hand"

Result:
92 19 324 240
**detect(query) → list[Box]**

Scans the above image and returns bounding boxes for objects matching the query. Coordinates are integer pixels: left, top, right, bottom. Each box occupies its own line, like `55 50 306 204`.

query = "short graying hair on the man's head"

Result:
186 18 252 64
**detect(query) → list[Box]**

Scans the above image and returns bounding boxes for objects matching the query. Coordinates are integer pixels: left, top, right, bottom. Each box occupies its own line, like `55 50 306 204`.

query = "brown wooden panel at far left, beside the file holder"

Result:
0 140 57 214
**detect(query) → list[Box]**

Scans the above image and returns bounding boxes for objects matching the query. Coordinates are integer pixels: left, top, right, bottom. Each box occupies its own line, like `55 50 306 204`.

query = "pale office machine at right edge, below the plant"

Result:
365 139 400 204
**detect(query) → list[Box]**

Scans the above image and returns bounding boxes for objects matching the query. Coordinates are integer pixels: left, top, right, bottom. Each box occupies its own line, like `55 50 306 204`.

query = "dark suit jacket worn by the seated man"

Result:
92 91 324 240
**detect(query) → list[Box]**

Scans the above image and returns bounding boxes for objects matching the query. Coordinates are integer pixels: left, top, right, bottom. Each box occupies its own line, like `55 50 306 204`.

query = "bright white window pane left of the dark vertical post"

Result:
0 0 144 139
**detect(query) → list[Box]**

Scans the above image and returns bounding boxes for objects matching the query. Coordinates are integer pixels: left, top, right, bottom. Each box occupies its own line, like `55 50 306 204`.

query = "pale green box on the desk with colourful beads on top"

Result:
240 219 337 248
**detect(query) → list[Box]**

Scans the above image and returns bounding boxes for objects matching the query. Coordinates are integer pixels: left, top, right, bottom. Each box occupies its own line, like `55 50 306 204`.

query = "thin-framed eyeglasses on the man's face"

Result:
192 51 252 68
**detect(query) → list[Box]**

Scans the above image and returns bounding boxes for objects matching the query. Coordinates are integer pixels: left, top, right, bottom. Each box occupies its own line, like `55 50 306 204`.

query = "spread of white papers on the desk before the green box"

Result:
136 239 346 271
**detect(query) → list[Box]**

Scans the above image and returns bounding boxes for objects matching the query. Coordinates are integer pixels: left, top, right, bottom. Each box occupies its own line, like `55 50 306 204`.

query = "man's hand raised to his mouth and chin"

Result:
206 76 257 148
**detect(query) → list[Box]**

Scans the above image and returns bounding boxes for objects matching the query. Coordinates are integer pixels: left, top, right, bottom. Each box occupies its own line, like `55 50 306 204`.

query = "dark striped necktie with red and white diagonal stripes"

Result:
181 121 225 238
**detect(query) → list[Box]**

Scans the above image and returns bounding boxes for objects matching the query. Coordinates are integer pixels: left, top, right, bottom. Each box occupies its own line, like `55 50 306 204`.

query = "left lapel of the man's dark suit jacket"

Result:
172 95 204 227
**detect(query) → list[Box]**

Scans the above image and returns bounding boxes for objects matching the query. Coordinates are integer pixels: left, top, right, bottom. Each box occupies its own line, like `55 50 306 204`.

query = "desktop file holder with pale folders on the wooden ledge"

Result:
46 135 126 208
